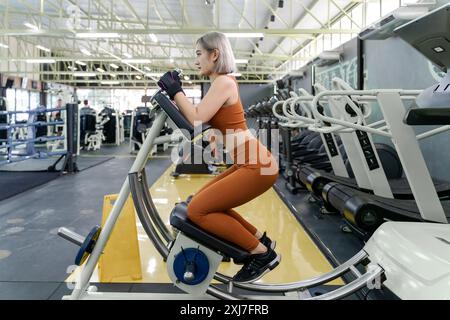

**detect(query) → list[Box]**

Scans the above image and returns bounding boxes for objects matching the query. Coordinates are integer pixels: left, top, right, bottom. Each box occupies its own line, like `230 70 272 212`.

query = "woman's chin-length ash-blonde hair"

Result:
196 31 236 74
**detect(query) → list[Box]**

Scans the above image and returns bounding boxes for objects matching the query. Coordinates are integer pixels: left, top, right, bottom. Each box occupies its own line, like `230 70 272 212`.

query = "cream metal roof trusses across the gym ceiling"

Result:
0 0 361 87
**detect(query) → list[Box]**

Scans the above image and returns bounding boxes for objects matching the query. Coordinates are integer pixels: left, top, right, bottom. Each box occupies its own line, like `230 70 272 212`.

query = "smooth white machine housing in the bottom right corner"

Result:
364 222 450 300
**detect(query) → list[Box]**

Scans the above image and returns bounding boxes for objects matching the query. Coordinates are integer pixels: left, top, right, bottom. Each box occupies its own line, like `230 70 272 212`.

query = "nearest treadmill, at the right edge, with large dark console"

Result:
324 4 450 239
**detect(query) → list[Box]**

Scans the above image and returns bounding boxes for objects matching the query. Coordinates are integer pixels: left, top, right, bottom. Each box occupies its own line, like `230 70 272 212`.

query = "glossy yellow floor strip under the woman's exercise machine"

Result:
68 167 343 285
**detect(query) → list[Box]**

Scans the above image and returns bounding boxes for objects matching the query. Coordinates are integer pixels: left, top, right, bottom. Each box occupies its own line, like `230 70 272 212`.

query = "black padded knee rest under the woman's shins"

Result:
170 202 250 264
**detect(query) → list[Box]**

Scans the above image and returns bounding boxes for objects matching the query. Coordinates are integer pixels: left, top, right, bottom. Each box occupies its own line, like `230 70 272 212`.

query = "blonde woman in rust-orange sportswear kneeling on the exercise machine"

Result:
158 32 281 283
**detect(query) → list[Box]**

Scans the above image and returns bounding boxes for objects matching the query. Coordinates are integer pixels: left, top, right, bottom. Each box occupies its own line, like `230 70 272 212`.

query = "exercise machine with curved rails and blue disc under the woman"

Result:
59 92 392 299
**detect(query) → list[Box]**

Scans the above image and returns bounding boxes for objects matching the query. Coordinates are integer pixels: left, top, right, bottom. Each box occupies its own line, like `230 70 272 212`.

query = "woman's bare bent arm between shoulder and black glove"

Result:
174 76 237 125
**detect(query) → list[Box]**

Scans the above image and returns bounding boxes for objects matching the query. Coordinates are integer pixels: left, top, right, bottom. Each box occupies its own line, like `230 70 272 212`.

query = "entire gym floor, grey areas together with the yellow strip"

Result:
0 144 370 300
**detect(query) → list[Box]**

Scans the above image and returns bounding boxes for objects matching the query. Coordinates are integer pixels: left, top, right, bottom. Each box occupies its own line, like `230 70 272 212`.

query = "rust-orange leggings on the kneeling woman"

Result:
188 145 278 252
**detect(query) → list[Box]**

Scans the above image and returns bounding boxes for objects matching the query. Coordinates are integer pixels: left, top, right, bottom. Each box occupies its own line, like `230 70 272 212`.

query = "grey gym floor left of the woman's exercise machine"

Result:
0 145 170 299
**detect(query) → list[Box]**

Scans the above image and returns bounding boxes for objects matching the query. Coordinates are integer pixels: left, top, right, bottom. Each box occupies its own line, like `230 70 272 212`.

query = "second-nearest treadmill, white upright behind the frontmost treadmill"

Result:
297 79 450 200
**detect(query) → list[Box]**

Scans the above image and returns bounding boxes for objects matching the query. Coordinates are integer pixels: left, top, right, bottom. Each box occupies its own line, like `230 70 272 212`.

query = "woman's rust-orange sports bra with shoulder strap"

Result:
209 76 248 135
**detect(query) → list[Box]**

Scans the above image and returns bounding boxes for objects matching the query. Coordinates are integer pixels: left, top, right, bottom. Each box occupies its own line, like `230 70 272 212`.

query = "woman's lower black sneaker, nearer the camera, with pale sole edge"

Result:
233 249 281 283
